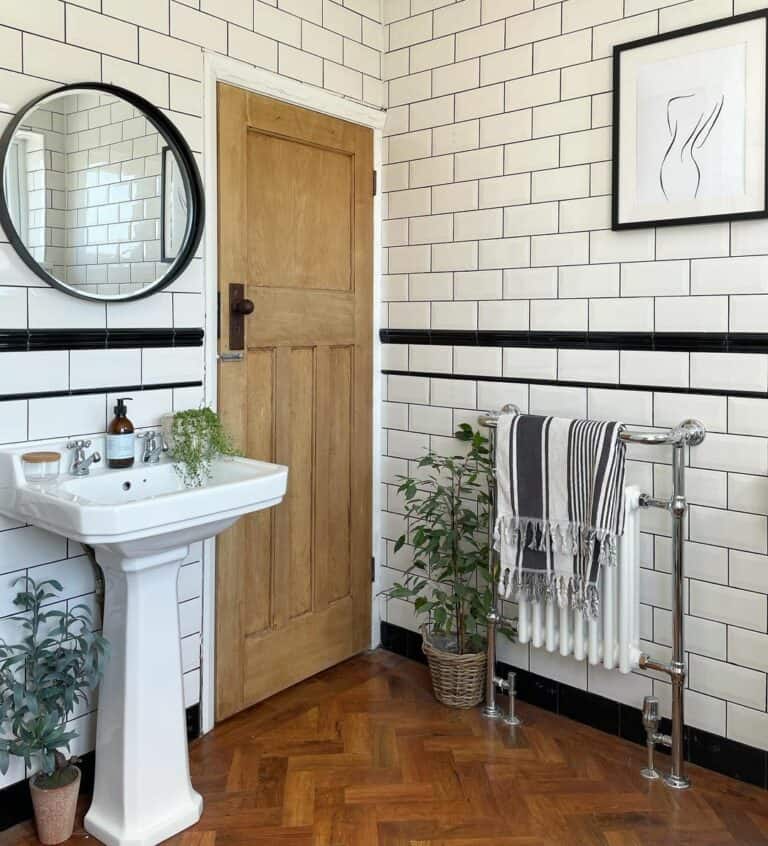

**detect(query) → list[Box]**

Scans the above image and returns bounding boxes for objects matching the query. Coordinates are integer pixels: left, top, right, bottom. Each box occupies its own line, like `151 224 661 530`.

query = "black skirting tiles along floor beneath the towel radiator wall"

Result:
381 621 768 790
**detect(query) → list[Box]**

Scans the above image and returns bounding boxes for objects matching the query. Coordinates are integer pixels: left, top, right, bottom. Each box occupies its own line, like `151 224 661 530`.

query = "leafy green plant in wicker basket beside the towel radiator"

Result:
389 423 510 708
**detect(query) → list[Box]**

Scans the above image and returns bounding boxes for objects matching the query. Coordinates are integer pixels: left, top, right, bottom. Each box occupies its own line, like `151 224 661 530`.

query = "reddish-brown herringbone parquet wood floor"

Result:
0 652 768 846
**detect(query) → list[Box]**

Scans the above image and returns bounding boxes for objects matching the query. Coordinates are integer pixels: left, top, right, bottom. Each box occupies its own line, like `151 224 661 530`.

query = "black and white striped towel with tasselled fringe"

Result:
496 414 625 616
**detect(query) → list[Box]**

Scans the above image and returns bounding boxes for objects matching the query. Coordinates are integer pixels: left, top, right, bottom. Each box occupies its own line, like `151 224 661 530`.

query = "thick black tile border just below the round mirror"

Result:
0 328 204 352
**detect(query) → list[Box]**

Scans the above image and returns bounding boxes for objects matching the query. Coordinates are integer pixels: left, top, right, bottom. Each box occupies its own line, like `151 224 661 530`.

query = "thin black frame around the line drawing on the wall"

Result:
611 9 768 231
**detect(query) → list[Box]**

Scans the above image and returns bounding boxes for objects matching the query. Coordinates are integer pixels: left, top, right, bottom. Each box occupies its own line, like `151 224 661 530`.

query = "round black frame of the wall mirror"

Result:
0 82 205 303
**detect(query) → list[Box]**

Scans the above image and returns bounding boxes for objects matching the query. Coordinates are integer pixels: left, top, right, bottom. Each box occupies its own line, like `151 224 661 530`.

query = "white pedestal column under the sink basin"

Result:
85 546 203 846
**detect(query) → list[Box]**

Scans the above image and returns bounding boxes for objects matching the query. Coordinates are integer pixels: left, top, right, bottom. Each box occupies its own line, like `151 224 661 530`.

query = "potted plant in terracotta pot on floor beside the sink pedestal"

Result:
0 577 109 844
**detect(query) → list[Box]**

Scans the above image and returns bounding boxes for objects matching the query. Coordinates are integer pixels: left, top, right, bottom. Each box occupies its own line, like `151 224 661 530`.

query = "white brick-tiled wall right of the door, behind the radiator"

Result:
378 0 768 749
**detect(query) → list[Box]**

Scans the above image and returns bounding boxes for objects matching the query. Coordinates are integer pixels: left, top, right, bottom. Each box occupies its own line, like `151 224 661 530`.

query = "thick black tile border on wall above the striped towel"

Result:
379 329 768 353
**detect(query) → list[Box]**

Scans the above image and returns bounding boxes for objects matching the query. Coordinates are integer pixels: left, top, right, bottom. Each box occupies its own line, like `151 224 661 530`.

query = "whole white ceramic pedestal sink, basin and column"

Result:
0 450 288 846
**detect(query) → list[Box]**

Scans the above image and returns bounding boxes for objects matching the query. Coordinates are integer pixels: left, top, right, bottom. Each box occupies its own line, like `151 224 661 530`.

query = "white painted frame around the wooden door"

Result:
200 51 386 732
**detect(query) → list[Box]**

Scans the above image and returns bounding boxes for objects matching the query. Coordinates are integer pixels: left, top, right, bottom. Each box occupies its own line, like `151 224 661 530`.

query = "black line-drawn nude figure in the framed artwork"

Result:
658 92 725 202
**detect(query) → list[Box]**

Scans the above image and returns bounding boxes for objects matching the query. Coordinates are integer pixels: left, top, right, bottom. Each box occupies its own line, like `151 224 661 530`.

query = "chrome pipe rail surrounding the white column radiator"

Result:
478 405 706 789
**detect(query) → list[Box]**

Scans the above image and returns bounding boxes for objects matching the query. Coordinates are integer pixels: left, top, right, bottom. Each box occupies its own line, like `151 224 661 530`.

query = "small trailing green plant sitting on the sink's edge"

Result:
162 407 237 488
